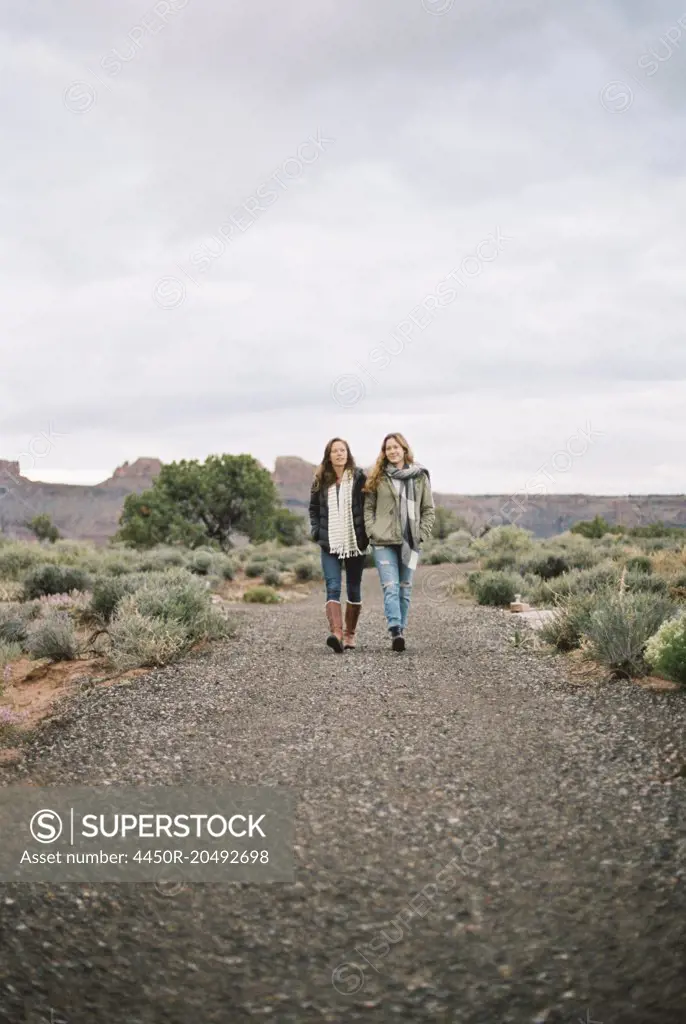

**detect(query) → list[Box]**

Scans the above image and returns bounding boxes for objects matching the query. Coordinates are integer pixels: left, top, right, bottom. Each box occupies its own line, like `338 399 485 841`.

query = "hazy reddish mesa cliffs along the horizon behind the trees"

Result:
0 456 686 544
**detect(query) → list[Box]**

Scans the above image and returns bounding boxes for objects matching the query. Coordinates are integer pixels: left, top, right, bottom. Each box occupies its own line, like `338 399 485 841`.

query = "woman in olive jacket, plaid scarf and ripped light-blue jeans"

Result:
365 433 436 651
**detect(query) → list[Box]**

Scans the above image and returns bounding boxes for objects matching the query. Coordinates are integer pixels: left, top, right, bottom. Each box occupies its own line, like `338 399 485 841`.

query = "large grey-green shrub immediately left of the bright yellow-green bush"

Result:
585 592 675 678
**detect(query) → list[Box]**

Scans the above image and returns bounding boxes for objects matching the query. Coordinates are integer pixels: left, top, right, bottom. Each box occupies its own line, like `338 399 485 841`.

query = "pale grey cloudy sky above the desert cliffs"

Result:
0 0 686 494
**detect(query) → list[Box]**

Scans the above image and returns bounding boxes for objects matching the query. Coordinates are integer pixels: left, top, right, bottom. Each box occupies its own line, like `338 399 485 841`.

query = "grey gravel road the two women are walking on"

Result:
0 567 686 1024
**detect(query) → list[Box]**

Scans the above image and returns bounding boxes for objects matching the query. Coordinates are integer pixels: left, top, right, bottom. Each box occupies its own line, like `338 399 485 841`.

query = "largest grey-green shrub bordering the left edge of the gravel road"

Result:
109 568 226 668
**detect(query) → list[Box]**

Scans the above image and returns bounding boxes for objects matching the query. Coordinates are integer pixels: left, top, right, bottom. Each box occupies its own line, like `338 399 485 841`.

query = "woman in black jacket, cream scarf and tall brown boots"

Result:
309 437 370 654
